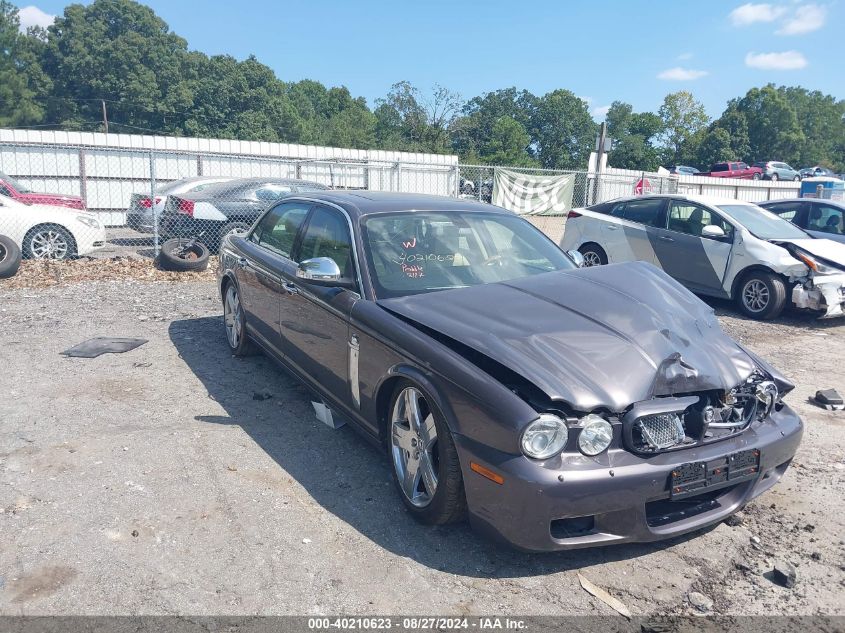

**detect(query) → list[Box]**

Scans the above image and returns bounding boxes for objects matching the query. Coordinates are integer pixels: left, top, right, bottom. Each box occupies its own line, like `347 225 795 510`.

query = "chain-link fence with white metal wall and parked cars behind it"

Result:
0 143 744 259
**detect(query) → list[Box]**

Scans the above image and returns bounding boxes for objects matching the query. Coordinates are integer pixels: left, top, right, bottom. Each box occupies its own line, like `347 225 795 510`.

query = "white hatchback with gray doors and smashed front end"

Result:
561 195 845 319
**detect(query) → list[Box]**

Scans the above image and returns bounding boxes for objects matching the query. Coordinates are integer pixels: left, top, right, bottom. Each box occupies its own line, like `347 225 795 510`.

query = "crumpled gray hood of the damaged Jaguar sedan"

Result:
378 262 755 412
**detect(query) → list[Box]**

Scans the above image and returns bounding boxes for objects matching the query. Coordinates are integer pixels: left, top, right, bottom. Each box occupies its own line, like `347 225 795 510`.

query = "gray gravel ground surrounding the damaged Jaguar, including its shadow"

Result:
0 281 845 615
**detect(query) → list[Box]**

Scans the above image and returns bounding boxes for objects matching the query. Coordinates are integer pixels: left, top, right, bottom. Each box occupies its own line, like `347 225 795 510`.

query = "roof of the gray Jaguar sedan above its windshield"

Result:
284 190 512 217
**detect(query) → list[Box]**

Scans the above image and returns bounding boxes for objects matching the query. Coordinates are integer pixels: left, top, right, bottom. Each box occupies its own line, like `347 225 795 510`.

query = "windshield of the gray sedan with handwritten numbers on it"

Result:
364 211 575 299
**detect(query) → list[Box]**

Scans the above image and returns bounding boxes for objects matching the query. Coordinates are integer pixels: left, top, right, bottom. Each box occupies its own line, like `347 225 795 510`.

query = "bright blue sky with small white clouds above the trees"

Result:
19 0 845 120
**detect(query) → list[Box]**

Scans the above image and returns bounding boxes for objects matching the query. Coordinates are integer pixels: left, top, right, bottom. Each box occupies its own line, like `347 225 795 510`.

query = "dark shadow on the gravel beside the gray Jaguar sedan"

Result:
169 317 712 578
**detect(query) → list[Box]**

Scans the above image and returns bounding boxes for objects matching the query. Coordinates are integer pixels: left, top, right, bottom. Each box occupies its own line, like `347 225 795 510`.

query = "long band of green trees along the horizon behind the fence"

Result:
0 0 845 171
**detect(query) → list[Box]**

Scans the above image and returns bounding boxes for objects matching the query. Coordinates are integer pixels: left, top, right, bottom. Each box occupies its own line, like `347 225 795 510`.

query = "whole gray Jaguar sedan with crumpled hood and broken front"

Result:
218 191 802 551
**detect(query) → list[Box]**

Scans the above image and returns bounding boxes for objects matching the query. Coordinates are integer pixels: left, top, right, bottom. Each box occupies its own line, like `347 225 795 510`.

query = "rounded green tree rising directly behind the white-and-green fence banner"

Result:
530 90 598 169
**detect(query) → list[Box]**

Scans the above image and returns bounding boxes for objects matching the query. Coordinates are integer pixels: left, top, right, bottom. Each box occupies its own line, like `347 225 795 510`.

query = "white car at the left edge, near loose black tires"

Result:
0 195 106 259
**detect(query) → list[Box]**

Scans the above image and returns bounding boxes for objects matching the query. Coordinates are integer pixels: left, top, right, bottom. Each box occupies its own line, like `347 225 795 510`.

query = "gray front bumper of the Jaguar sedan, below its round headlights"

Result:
455 406 803 551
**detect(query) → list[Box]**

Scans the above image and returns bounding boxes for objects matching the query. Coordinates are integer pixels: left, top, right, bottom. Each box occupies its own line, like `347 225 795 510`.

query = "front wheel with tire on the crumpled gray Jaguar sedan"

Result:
387 381 466 525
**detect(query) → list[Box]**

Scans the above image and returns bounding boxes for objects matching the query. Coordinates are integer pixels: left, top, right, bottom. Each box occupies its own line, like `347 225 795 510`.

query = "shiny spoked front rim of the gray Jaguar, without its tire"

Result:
390 387 438 508
